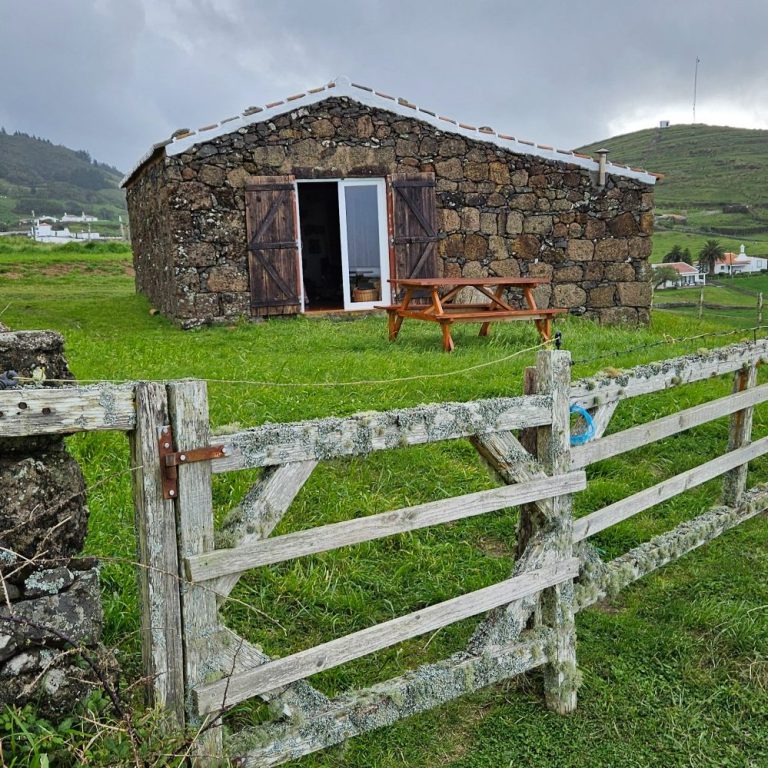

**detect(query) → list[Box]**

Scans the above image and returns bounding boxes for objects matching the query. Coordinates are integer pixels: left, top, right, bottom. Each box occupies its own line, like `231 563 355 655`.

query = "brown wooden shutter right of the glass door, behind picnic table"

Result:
389 173 440 278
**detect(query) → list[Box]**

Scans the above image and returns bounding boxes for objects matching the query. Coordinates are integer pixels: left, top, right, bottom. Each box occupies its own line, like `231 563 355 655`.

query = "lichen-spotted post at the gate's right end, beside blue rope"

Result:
518 350 578 714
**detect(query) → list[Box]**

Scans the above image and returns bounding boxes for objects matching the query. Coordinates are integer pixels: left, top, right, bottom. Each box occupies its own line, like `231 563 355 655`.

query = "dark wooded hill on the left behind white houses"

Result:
0 129 126 230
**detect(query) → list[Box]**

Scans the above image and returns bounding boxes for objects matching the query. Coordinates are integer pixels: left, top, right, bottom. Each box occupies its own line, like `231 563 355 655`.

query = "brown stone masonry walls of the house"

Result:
128 97 653 324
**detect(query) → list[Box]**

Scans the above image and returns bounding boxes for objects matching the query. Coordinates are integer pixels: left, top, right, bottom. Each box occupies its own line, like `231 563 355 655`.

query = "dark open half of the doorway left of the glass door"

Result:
298 181 344 310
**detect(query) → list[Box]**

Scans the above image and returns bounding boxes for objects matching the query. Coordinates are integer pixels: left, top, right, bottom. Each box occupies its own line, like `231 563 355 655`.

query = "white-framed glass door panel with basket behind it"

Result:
339 179 389 309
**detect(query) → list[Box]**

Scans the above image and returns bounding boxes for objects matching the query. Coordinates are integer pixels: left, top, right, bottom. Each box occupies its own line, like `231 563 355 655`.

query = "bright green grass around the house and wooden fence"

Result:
0 241 768 768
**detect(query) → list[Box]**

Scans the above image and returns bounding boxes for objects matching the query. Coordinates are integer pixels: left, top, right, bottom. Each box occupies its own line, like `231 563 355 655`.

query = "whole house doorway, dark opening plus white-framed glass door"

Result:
297 179 389 312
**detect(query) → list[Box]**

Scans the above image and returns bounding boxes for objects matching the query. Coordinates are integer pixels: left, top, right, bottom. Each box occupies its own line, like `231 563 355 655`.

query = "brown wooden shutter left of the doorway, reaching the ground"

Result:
245 176 301 316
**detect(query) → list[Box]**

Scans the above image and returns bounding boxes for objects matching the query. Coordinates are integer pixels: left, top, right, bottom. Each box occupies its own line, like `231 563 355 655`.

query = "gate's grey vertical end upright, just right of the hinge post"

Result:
168 381 223 768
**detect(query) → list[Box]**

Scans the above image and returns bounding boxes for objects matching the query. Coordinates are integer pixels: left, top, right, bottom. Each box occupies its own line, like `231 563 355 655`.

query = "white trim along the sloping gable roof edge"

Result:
120 77 656 187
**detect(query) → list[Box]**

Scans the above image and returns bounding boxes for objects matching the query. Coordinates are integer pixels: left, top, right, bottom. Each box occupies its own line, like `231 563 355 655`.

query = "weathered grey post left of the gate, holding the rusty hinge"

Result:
128 383 184 726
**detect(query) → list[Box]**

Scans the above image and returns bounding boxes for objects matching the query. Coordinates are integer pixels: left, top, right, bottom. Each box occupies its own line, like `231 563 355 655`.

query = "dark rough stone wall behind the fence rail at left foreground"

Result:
0 328 102 717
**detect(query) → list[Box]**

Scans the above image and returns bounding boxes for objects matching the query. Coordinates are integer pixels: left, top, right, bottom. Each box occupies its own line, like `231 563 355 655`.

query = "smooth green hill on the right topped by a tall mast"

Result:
578 125 768 210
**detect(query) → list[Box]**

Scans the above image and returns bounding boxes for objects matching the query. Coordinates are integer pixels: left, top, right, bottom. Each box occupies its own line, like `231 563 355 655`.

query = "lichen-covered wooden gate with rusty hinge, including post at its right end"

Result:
137 352 586 765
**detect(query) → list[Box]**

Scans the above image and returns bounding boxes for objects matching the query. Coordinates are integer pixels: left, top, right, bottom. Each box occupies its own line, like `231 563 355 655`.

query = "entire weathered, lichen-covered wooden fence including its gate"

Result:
0 341 768 766
